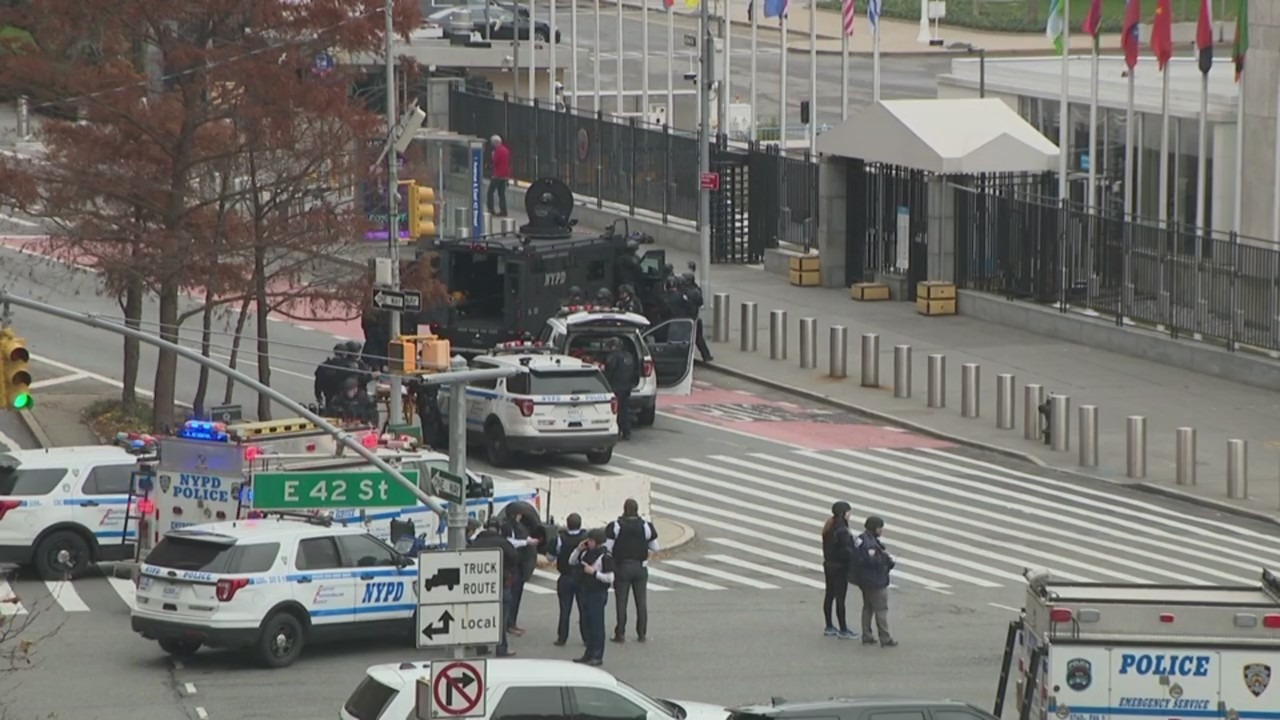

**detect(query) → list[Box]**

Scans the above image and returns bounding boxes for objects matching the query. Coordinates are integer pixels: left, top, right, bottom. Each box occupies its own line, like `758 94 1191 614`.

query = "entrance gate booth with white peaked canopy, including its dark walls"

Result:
817 99 1060 301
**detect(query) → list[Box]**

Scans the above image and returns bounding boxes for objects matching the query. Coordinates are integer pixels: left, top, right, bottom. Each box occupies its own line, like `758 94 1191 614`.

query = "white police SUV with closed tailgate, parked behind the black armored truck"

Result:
440 342 618 468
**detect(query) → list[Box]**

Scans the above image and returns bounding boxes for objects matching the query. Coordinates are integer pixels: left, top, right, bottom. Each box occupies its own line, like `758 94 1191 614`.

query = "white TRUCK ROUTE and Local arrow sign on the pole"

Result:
415 547 503 648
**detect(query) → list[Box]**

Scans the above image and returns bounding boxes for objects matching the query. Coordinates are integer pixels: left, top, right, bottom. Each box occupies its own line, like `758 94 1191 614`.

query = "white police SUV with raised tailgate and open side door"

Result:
539 305 696 425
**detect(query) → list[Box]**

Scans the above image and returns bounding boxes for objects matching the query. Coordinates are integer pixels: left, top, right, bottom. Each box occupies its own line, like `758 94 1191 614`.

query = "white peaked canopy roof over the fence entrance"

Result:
818 99 1057 174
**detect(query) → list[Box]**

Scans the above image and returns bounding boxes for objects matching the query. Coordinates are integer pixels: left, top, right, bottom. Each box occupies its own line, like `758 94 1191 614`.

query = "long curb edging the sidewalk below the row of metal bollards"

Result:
696 360 1280 525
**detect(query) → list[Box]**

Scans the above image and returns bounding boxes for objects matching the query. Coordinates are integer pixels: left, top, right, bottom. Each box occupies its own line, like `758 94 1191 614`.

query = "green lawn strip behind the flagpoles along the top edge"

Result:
818 0 1239 34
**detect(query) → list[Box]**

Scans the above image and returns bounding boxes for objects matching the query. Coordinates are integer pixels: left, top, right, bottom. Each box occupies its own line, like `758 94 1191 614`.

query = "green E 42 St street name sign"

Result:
253 470 419 510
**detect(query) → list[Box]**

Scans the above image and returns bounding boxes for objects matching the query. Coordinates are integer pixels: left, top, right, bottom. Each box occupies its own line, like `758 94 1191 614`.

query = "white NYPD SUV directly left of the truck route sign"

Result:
131 514 417 667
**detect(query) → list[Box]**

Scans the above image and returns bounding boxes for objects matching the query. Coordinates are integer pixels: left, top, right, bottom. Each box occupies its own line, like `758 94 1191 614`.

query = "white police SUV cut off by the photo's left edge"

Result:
0 446 137 580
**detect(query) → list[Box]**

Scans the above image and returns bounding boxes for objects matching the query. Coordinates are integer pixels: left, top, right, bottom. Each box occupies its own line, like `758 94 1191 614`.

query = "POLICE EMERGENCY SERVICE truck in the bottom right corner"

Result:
995 570 1280 720
